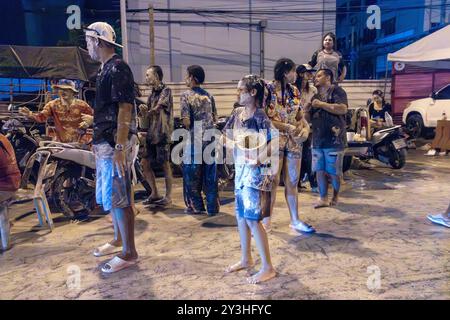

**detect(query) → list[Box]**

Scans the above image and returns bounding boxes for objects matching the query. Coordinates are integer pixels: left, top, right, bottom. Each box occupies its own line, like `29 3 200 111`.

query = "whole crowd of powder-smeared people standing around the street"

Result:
0 22 448 283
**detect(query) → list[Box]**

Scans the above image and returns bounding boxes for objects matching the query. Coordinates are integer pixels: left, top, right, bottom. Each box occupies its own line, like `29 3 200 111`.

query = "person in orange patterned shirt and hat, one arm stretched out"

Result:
19 80 94 143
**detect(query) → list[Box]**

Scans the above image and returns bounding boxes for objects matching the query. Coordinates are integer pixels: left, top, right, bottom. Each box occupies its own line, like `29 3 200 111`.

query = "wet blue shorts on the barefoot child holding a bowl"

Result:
234 186 263 221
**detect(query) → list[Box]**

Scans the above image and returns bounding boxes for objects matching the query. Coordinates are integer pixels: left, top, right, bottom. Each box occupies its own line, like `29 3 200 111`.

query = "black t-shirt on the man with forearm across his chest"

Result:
310 85 348 149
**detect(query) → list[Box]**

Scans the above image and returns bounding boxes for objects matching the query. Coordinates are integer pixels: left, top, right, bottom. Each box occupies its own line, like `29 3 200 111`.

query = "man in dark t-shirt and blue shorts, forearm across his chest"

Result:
306 69 348 208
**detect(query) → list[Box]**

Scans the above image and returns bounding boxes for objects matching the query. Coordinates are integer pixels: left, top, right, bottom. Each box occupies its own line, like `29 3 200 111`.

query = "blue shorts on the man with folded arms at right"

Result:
312 148 344 176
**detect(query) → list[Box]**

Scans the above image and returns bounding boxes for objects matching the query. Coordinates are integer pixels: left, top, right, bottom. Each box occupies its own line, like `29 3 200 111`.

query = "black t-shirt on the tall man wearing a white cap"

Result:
93 55 136 147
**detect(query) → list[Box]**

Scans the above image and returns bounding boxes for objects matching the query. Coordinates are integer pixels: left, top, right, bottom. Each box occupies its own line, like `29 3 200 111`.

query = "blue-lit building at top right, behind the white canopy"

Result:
336 0 450 79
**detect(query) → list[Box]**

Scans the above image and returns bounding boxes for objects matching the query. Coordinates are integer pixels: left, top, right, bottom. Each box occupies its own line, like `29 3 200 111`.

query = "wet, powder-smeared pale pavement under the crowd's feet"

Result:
0 146 450 299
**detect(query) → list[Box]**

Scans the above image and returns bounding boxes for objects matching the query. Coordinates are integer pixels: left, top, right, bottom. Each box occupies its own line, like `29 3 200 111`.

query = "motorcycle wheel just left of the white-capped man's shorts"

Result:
52 170 95 219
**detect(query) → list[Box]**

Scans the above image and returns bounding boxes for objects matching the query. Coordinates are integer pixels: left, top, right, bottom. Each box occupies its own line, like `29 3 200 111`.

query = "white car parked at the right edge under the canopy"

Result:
403 84 450 138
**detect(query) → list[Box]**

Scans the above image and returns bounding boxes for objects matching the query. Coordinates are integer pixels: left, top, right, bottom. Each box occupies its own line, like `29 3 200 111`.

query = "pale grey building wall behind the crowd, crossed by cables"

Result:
127 0 336 82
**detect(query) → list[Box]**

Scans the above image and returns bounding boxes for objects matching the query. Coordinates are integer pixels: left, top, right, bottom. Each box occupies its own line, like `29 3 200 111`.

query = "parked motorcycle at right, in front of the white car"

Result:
343 126 407 172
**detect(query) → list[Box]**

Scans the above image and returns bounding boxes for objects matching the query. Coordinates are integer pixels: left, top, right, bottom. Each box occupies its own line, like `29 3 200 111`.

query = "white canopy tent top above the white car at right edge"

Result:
388 25 450 69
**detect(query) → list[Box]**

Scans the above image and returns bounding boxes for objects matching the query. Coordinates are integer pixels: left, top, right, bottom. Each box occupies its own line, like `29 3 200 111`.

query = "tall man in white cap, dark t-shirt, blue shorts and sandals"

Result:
86 22 138 273
